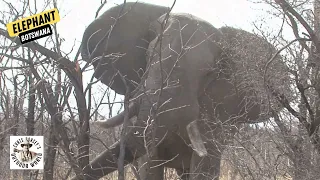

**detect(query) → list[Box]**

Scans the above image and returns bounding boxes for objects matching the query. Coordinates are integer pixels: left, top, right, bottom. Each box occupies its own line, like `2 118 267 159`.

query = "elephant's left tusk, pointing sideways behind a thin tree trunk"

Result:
93 102 138 129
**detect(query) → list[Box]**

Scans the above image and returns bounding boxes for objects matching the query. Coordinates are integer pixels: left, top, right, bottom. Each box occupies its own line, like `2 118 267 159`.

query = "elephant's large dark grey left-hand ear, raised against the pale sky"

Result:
81 2 169 95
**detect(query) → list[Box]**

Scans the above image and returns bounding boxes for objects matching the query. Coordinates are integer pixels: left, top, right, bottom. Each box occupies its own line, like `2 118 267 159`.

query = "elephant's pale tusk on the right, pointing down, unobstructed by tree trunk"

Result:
187 120 208 157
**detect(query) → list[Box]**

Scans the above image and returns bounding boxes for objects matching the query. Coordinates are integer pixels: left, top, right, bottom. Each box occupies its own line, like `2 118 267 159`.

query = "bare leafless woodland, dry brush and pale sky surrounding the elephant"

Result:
0 0 320 180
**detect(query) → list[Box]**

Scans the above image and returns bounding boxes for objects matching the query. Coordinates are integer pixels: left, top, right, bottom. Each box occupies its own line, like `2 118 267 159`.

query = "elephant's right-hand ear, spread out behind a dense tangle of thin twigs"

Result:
220 27 292 120
